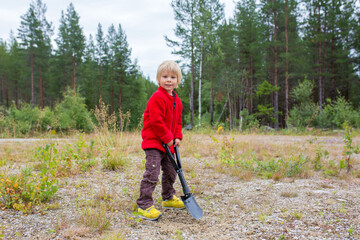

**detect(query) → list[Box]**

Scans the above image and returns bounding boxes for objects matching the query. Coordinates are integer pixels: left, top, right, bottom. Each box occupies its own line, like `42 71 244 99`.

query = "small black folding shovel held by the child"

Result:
163 144 203 220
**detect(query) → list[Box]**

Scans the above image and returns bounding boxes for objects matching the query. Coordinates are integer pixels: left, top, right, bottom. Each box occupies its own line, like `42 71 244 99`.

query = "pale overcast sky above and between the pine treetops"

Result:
0 0 235 81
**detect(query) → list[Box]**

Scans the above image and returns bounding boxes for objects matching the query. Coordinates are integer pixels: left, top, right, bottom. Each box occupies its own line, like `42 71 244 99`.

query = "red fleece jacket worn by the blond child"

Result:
141 87 183 153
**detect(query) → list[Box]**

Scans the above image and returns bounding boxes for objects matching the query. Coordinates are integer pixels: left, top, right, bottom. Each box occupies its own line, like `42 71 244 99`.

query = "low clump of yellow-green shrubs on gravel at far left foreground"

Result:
0 135 96 212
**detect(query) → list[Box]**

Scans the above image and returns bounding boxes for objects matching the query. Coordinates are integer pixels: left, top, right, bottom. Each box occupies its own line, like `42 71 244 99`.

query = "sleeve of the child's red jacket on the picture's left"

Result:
148 96 174 143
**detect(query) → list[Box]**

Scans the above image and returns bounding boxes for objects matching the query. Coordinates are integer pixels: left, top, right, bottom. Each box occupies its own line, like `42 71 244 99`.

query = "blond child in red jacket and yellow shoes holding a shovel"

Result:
136 61 185 221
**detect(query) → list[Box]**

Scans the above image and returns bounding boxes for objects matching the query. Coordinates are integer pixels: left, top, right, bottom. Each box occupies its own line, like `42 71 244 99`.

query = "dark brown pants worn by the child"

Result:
136 149 176 209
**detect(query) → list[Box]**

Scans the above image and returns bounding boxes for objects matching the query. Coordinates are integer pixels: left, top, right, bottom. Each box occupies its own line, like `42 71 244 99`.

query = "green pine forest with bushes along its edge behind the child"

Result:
0 0 360 135
